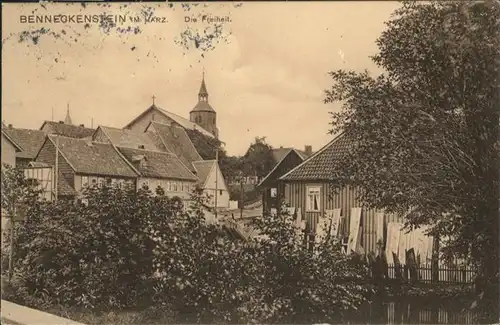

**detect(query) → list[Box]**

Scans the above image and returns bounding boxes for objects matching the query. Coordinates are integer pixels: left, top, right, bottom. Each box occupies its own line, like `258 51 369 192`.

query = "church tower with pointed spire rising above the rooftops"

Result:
189 73 219 137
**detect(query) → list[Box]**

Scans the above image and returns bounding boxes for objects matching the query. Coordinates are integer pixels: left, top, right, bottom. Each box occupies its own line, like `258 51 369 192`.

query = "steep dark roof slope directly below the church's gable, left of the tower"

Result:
151 122 203 167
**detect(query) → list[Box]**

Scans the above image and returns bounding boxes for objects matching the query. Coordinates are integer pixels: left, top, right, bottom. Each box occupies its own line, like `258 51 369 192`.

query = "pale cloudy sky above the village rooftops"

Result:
2 1 399 155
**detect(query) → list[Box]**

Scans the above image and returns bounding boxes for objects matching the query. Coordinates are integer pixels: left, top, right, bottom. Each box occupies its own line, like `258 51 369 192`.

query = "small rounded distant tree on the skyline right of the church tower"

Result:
242 137 276 178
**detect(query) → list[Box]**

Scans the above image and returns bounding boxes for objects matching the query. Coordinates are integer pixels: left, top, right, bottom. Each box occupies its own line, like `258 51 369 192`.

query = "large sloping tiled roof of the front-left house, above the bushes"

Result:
49 135 137 177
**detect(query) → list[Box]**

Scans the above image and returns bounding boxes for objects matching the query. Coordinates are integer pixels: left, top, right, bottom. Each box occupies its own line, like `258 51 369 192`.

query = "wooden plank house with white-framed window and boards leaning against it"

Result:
279 134 420 253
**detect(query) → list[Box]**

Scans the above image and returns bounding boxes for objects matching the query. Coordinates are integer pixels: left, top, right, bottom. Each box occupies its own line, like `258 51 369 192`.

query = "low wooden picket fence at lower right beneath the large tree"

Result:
388 264 476 284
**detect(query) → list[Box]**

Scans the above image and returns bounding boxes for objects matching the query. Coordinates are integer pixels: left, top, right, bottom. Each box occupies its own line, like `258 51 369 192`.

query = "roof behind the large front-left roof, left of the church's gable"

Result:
99 126 161 151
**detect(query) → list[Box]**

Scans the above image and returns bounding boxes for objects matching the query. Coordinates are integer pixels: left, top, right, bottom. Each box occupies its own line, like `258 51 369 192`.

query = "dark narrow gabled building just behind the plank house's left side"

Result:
257 146 312 213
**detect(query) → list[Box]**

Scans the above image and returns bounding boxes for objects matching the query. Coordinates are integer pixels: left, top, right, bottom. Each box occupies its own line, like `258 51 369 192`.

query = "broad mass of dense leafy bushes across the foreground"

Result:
5 166 369 323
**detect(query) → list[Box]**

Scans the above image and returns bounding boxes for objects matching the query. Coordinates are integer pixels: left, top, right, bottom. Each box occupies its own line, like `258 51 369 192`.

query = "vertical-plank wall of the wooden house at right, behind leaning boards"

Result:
285 182 402 252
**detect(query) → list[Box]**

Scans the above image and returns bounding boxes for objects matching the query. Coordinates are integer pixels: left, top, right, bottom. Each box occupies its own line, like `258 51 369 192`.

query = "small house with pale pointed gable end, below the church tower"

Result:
193 160 229 209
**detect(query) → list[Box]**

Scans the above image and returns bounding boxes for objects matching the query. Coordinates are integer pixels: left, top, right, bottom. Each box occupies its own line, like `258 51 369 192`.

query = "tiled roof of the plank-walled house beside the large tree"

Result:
280 134 351 181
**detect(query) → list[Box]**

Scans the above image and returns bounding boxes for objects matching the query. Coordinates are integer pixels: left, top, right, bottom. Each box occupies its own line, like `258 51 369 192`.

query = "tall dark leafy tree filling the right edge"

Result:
325 1 500 316
